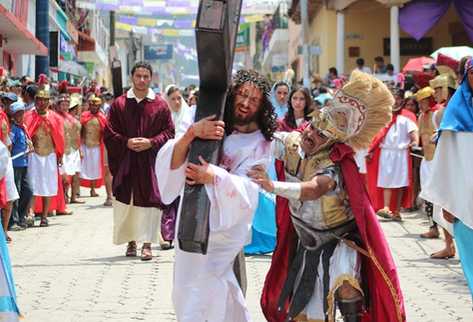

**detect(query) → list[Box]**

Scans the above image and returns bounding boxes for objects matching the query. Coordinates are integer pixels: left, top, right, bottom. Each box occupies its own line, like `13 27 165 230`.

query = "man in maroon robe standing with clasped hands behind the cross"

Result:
105 62 174 260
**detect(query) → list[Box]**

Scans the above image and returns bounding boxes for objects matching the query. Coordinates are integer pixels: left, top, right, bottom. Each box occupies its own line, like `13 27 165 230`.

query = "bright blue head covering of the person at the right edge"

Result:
439 58 473 132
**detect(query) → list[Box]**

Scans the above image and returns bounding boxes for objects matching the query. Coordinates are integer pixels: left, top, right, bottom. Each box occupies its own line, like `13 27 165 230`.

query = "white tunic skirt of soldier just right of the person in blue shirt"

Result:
28 152 58 197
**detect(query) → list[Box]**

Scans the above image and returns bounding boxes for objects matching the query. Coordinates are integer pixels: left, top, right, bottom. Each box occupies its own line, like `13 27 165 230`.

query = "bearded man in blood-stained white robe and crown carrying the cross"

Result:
156 70 276 322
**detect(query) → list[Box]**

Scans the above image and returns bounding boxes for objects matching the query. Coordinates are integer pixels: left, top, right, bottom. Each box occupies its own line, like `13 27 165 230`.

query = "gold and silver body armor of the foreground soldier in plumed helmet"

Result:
283 132 354 245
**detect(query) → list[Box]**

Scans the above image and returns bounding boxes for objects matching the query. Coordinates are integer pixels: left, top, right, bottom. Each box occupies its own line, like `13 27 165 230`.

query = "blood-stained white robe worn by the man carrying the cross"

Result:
156 131 271 322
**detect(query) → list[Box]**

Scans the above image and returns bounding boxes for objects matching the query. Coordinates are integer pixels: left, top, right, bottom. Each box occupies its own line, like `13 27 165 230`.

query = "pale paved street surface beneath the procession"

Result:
10 187 473 322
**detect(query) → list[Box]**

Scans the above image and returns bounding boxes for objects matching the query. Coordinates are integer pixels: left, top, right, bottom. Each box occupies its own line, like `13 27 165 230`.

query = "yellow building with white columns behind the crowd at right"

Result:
288 0 472 79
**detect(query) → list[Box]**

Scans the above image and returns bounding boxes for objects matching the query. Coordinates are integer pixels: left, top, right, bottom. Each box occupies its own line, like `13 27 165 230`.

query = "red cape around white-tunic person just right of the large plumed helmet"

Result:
366 108 417 211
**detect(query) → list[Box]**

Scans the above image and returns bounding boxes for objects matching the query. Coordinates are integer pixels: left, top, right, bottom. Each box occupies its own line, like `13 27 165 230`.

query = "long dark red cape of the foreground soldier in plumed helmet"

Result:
261 144 406 322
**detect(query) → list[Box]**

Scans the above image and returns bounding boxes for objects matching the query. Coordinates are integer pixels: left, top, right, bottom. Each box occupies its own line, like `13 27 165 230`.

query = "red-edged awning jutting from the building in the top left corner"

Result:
0 5 48 56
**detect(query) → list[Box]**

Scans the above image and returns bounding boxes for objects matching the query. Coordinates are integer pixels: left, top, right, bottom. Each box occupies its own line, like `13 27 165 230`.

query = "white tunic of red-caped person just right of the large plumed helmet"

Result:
378 115 417 188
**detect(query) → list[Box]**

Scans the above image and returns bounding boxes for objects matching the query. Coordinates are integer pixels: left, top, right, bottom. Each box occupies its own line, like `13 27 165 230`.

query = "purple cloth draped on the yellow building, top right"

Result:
399 0 473 41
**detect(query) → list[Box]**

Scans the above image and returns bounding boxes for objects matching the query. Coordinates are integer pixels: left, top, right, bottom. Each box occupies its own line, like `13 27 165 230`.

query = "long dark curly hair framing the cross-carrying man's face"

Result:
223 86 278 141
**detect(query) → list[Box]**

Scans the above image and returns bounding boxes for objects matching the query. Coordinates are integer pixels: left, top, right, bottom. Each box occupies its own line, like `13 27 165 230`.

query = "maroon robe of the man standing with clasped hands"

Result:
104 93 174 209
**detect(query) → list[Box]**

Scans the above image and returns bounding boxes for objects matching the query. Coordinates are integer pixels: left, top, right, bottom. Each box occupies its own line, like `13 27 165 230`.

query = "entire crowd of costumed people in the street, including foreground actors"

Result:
0 51 473 322
